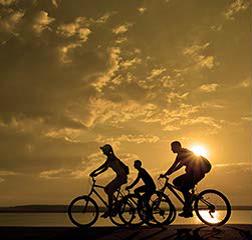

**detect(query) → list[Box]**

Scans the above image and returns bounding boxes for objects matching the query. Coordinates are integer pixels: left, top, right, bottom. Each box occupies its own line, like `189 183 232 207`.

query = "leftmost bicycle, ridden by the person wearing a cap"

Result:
68 177 128 228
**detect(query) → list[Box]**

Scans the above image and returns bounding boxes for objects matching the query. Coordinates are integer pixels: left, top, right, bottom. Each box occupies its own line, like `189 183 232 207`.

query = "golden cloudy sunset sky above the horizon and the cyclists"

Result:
0 0 252 205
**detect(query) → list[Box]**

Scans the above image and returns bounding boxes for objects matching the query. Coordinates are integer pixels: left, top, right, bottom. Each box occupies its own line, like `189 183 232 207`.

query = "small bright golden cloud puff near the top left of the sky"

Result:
32 11 55 34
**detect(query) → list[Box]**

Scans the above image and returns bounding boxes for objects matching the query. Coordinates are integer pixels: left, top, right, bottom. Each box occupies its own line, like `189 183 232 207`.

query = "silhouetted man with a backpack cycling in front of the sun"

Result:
160 141 211 217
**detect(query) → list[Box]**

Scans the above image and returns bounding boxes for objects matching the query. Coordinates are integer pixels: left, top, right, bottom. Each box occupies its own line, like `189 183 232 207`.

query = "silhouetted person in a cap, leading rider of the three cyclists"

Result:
90 144 129 218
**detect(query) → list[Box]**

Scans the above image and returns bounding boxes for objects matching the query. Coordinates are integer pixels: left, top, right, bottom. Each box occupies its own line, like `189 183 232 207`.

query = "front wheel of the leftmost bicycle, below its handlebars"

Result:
68 195 99 228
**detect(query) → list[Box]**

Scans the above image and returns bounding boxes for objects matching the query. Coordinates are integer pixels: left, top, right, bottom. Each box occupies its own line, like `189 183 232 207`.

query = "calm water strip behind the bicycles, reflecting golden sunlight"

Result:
0 210 252 226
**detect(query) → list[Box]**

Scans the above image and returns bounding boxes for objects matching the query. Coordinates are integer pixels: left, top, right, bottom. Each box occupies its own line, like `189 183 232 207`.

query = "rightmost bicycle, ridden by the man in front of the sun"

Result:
151 177 231 226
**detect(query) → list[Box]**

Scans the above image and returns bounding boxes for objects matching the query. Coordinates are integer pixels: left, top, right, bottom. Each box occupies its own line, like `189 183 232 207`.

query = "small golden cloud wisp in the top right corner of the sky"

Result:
224 0 250 20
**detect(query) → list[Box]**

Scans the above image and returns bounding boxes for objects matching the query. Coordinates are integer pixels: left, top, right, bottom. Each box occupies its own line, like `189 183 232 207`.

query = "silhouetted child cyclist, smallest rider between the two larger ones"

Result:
126 160 156 217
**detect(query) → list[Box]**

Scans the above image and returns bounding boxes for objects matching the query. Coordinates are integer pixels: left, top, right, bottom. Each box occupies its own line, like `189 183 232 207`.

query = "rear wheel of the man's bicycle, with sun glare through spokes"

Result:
194 189 231 226
